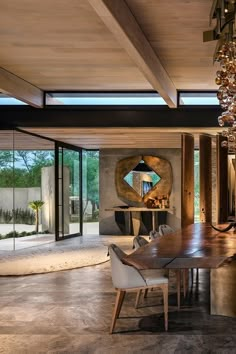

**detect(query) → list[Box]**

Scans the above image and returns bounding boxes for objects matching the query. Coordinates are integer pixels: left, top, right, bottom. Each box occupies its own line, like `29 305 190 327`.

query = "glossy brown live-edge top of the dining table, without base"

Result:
123 223 236 270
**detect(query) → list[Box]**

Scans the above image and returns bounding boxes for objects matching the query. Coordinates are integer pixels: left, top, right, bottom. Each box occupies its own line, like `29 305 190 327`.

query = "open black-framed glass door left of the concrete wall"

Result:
55 142 82 240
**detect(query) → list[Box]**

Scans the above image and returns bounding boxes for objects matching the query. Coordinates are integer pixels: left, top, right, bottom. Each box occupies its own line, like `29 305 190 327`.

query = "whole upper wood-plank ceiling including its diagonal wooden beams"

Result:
0 0 217 107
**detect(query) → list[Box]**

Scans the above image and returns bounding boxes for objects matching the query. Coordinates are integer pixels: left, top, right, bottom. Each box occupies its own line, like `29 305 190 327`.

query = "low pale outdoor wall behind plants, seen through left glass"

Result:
0 187 41 210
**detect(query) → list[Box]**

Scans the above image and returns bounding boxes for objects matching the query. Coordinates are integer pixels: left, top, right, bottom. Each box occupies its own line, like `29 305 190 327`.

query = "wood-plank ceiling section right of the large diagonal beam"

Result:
126 0 217 90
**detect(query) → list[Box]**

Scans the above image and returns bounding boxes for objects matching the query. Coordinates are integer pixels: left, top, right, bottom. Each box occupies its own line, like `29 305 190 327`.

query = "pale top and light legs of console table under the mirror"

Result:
105 207 170 236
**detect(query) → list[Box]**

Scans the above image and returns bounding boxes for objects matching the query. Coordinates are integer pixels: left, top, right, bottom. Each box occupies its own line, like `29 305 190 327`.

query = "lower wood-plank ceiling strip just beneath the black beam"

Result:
7 127 218 149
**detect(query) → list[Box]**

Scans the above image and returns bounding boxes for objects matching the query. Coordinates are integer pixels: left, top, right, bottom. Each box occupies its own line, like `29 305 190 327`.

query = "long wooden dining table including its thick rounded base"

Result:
122 223 236 316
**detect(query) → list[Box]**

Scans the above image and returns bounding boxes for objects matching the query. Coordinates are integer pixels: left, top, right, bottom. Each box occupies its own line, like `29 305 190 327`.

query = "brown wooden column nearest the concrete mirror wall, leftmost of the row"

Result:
181 134 194 227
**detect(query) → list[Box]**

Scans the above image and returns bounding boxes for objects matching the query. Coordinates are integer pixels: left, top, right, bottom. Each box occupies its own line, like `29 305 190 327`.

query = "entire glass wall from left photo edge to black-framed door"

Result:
0 130 55 250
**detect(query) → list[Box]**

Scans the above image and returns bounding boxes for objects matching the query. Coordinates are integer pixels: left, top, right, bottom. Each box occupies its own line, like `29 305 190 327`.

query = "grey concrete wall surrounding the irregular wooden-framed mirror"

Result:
99 149 181 235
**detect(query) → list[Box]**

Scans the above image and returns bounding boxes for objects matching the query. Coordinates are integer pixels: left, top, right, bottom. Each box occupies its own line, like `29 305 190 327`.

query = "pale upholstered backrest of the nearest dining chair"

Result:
108 244 146 289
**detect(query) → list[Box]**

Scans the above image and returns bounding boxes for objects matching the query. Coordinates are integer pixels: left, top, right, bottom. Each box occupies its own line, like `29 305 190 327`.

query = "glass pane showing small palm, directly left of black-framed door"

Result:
13 131 55 249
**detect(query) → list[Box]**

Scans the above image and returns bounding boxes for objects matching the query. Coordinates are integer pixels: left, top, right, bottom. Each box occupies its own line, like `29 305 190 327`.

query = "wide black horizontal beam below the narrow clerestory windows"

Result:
0 106 222 131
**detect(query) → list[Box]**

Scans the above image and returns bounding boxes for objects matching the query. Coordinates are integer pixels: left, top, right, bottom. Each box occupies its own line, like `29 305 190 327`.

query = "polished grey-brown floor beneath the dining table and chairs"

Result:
0 237 236 354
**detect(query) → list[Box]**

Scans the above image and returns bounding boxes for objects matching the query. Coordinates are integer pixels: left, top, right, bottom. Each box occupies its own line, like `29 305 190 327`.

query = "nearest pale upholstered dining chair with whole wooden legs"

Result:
108 244 168 334
